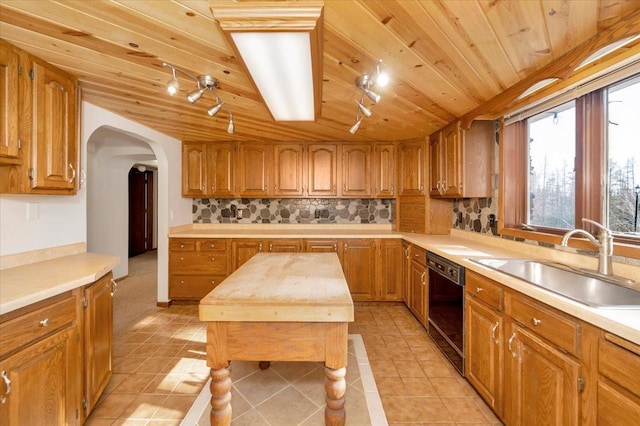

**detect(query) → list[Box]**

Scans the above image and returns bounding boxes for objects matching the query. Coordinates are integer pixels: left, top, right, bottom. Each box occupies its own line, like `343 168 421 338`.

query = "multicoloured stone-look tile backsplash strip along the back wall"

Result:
192 198 395 224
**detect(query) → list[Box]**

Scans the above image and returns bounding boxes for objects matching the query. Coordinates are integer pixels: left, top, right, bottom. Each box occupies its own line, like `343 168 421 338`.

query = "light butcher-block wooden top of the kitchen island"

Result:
200 253 353 322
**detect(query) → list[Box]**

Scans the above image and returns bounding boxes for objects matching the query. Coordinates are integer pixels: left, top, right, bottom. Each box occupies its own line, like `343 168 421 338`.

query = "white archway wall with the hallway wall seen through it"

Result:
82 103 192 302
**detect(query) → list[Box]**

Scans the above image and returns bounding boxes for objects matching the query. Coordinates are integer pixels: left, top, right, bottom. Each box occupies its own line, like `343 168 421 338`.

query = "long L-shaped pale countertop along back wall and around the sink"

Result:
169 224 640 344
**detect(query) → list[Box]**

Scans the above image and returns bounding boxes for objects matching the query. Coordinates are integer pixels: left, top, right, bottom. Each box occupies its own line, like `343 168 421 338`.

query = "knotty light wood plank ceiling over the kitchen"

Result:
0 0 640 141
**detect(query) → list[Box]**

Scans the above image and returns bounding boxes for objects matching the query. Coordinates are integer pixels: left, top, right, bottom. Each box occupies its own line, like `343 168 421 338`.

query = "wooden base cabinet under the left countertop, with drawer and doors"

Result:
0 273 115 426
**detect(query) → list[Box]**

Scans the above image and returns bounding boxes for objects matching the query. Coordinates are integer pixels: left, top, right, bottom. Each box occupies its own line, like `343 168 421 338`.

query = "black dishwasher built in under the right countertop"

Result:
426 251 464 376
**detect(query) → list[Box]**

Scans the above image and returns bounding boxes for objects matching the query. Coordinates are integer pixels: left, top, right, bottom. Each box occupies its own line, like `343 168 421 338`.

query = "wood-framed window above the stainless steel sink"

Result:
500 74 640 257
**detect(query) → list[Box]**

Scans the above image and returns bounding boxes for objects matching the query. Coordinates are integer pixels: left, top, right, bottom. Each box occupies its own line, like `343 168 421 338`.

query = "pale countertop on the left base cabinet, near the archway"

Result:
0 253 120 314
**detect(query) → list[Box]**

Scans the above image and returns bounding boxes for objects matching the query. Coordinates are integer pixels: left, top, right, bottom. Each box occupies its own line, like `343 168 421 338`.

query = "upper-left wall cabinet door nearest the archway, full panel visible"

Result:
31 62 79 193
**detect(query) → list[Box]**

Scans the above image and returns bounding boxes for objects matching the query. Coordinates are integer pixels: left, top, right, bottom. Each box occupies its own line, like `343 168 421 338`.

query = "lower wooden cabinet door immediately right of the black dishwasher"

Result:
465 295 504 416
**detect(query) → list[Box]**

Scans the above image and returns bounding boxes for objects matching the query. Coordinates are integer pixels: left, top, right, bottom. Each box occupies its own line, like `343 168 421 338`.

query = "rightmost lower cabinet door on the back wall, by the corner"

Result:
376 240 404 300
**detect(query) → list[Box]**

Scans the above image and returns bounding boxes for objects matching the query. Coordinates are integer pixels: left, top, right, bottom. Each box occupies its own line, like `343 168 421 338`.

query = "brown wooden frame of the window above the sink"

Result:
498 79 640 259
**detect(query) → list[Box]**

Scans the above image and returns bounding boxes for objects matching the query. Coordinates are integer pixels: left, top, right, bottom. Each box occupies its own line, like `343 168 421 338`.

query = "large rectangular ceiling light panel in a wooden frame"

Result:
209 0 324 121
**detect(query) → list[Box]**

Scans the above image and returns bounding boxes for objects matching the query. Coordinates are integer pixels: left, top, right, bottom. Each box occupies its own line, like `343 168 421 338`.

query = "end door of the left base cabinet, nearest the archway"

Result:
84 273 115 414
